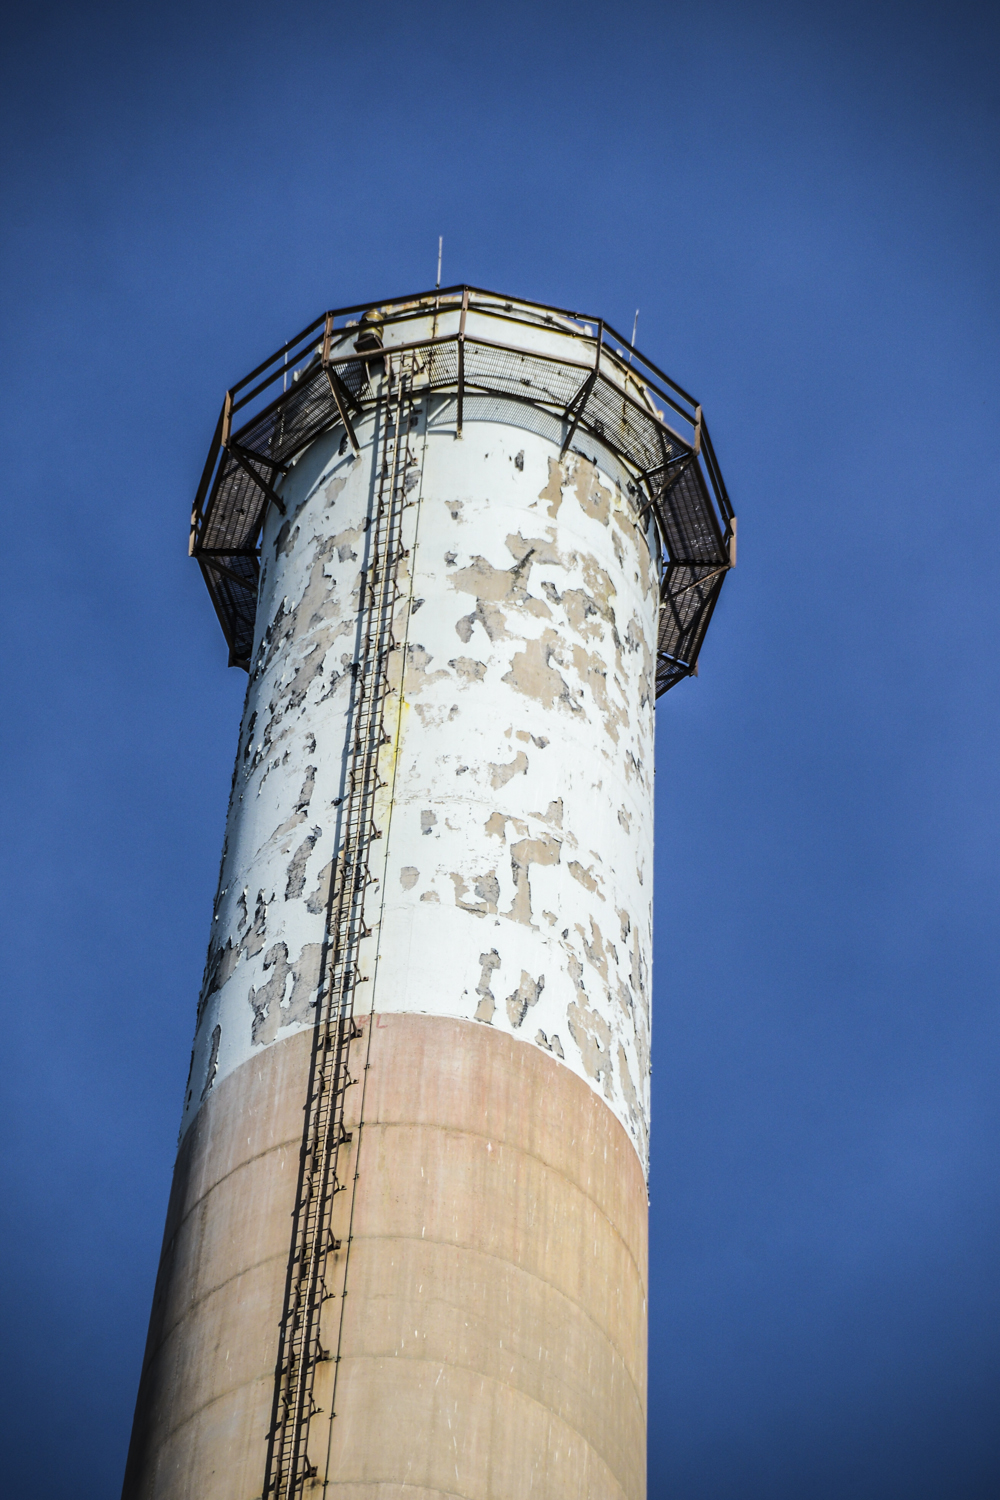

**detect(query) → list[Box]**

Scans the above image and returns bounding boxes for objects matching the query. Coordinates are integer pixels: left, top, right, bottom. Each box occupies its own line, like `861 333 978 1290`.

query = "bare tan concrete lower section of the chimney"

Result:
124 1016 646 1500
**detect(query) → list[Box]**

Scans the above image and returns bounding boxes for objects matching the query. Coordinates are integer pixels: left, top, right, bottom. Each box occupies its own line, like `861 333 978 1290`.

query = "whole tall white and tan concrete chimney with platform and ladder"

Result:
124 288 735 1500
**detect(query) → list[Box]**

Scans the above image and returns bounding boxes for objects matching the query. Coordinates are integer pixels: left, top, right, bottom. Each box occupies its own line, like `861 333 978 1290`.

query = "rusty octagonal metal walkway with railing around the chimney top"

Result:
189 287 736 695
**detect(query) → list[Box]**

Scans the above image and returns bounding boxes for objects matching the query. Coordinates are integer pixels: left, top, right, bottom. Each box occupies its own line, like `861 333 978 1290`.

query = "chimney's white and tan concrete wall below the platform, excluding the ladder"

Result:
131 310 658 1500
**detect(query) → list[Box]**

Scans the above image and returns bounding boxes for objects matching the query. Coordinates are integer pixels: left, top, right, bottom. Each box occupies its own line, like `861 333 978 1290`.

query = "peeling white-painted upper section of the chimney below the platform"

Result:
183 369 657 1161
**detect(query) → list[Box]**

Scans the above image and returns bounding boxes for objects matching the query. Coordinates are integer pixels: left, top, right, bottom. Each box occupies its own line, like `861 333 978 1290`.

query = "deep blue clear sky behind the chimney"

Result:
0 0 1000 1500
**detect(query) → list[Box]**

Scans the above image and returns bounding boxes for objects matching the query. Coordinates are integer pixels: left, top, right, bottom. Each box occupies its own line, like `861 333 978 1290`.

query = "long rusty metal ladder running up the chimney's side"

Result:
262 356 412 1500
